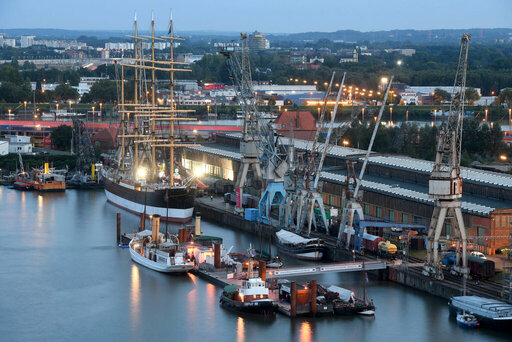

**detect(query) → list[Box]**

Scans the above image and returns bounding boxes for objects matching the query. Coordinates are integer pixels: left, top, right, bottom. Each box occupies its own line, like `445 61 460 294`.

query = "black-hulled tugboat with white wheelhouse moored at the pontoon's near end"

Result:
220 260 277 316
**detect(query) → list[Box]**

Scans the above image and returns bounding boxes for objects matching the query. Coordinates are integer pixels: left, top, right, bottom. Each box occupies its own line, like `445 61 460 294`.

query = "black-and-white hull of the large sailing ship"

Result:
105 179 195 222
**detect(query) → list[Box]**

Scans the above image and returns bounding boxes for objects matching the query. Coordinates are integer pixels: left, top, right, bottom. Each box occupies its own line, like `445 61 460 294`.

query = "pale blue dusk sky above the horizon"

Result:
0 0 512 33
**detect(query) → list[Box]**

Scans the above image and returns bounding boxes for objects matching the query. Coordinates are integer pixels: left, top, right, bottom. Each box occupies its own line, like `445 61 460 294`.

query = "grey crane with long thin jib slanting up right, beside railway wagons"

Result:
337 76 393 249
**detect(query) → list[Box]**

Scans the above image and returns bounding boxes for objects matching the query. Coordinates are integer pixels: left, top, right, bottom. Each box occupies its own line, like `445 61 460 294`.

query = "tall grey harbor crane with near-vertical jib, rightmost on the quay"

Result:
423 34 471 279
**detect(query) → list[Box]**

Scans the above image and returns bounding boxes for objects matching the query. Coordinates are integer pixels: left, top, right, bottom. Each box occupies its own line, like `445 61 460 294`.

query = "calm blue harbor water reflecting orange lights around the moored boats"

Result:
0 187 510 342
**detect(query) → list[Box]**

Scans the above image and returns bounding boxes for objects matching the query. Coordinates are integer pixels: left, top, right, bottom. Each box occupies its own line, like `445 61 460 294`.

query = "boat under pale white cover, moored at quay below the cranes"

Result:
276 229 324 260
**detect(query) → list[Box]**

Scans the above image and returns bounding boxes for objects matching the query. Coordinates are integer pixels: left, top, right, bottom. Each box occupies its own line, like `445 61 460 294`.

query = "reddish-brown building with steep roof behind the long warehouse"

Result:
274 111 316 140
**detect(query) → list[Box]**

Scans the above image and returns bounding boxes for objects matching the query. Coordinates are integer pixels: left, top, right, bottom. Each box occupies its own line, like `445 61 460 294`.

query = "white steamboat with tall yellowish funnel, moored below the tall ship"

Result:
129 215 194 273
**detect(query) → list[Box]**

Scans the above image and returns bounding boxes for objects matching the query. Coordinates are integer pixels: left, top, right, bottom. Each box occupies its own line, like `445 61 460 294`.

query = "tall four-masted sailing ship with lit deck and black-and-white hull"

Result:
104 15 198 222
